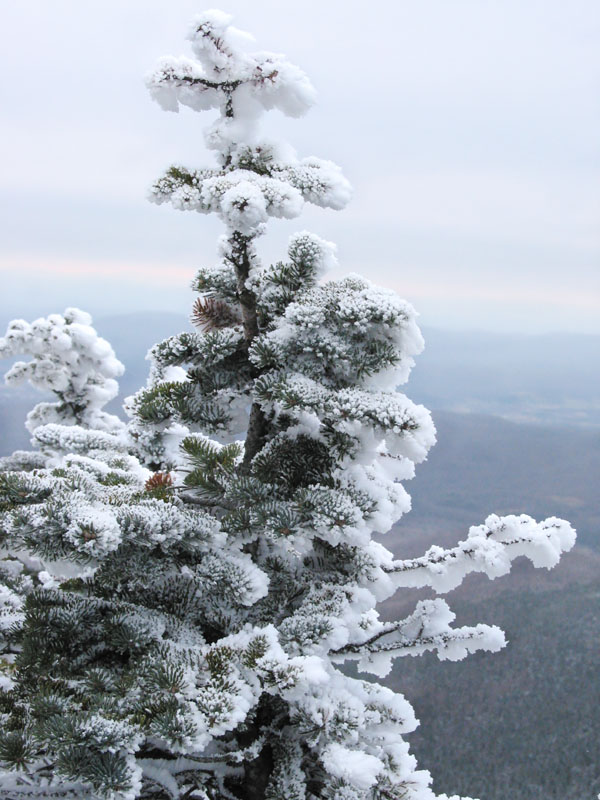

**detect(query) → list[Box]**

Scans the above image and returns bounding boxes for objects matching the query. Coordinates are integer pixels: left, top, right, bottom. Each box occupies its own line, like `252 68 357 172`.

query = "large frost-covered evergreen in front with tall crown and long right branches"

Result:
0 11 574 800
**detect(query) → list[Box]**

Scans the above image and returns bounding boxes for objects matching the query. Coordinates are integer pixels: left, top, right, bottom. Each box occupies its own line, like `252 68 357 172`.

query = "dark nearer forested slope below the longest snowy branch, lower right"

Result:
380 564 600 800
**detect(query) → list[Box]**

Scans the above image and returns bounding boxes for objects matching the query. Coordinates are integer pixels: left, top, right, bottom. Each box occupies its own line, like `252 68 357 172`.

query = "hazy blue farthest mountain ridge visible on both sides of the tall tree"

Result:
0 311 600 428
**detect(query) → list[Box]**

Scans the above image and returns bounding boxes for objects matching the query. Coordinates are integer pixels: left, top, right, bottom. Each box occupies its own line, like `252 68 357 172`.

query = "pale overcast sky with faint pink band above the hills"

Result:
0 0 600 333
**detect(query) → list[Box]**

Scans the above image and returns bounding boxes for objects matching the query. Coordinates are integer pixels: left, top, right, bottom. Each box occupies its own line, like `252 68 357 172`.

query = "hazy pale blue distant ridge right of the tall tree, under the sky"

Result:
408 329 600 427
